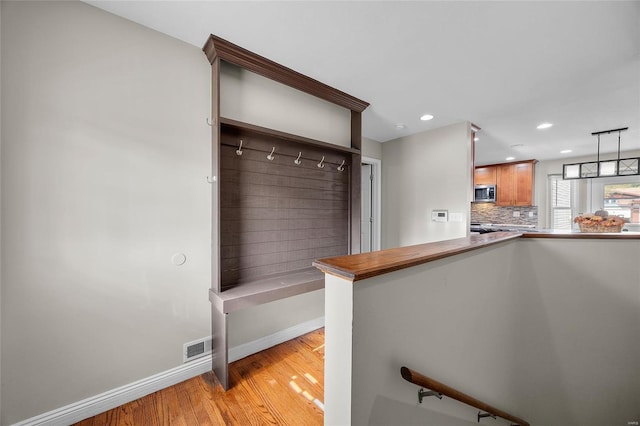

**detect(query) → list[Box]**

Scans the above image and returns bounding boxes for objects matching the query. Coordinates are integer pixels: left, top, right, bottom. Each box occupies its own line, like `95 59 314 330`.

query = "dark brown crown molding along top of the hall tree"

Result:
202 34 369 112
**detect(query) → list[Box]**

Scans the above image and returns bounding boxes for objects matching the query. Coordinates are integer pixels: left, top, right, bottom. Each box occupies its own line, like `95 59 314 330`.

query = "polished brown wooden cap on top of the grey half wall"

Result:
313 231 640 281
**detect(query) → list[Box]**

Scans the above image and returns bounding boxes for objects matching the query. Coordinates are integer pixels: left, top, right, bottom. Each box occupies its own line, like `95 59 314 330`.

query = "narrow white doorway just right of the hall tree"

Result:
360 157 382 253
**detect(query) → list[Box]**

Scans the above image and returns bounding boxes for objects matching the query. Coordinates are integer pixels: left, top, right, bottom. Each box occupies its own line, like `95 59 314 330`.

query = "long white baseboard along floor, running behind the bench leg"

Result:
13 317 324 426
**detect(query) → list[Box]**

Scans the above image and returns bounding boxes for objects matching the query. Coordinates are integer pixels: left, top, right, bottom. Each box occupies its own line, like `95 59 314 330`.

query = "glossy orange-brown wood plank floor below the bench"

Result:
75 329 324 426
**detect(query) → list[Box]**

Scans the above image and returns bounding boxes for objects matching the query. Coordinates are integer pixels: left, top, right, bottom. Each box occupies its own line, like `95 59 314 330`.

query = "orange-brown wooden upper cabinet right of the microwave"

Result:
495 160 536 206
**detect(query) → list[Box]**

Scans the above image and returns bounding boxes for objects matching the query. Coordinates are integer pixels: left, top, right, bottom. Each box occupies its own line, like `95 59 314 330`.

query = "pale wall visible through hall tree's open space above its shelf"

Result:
220 62 351 147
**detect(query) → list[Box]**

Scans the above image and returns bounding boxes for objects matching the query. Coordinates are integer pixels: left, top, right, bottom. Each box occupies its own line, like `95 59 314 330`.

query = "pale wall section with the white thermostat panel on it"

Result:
382 122 472 248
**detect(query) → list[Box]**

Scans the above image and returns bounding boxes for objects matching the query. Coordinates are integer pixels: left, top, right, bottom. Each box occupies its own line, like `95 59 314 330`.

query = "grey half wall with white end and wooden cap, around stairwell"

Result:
314 232 640 425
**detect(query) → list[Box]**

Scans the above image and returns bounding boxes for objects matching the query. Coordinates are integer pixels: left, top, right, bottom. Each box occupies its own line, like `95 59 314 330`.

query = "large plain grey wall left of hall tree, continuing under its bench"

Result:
0 2 324 424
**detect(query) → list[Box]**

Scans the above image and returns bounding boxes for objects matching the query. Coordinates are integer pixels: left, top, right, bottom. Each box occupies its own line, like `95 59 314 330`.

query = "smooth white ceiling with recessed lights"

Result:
87 1 640 164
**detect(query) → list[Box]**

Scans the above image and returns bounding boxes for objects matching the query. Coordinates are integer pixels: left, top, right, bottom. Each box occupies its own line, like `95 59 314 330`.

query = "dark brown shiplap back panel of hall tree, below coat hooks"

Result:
220 133 349 290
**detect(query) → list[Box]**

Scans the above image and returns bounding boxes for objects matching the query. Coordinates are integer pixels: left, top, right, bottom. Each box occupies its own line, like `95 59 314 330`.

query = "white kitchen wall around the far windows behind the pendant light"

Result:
535 151 640 228
